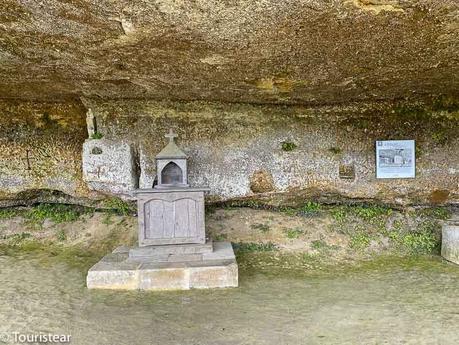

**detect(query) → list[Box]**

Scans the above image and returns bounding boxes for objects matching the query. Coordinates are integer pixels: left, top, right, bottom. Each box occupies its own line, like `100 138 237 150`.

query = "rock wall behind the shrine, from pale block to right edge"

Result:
86 100 459 204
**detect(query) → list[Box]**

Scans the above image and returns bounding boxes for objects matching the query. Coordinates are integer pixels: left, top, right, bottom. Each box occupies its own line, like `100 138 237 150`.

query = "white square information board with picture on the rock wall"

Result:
376 140 416 178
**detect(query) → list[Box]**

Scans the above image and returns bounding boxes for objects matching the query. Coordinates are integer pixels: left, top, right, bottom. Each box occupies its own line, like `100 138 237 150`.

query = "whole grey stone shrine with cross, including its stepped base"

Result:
87 131 238 290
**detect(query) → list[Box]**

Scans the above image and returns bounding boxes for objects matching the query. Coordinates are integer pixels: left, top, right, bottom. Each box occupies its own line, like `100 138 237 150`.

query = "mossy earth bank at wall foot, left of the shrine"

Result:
0 202 138 270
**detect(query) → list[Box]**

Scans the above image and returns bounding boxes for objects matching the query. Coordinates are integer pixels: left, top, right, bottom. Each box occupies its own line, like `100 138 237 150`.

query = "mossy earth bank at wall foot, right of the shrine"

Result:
210 201 451 271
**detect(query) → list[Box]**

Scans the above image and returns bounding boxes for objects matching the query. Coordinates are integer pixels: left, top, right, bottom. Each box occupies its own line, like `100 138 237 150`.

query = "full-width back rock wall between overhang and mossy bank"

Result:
0 99 459 205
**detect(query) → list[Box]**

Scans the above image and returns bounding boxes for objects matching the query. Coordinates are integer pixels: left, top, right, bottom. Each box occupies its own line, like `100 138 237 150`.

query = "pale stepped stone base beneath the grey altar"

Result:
86 242 238 290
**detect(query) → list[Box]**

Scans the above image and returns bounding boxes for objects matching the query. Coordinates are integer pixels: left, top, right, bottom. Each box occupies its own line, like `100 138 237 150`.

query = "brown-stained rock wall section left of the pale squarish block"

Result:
0 101 90 205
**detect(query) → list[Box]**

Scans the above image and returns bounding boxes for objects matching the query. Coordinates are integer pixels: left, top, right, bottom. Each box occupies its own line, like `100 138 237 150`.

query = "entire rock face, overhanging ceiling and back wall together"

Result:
0 0 459 205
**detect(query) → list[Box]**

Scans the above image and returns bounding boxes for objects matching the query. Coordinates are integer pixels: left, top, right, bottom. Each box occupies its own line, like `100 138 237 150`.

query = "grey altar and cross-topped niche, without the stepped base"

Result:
135 128 208 247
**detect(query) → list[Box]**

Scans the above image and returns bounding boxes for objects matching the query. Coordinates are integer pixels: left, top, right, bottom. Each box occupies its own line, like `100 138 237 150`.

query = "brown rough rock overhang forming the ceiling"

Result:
0 0 459 104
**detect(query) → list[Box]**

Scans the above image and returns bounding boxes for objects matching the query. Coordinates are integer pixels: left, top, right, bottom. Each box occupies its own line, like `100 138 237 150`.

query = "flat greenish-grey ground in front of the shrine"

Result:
0 253 459 345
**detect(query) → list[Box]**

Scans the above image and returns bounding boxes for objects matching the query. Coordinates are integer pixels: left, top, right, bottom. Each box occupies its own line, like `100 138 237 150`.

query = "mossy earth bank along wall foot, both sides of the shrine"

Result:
0 199 451 273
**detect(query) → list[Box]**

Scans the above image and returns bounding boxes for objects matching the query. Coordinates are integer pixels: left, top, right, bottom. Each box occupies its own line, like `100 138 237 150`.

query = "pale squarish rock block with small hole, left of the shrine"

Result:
83 139 138 195
